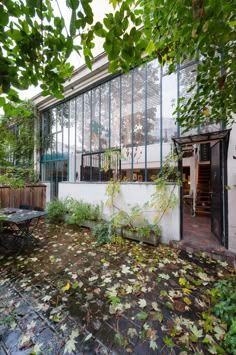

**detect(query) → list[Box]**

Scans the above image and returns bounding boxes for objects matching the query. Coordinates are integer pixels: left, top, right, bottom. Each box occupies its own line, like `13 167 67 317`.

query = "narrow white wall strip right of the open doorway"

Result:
228 124 236 253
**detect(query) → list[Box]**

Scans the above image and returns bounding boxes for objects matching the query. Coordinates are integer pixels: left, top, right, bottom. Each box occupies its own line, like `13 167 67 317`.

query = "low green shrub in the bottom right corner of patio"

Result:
211 276 236 354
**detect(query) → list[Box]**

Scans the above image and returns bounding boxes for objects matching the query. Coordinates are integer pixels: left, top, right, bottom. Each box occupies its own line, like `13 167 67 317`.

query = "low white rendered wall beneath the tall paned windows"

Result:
59 182 180 243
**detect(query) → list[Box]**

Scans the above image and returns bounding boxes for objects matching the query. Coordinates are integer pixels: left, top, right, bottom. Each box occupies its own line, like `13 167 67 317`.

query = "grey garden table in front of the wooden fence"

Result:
0 208 47 250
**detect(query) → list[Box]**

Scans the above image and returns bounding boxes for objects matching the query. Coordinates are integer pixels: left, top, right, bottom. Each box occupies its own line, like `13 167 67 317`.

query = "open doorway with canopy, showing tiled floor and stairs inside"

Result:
174 130 229 250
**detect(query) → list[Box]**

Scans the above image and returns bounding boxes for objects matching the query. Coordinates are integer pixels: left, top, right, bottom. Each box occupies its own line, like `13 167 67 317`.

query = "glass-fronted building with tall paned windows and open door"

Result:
33 54 236 250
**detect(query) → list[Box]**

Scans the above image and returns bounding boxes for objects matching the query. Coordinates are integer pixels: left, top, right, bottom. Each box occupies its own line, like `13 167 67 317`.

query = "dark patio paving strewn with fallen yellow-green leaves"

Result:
0 222 234 355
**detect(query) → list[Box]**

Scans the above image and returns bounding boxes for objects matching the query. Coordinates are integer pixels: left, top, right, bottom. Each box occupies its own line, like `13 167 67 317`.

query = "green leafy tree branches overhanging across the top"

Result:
0 0 236 131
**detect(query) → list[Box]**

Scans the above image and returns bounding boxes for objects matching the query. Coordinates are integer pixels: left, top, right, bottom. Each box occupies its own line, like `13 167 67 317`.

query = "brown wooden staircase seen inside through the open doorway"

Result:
196 163 211 216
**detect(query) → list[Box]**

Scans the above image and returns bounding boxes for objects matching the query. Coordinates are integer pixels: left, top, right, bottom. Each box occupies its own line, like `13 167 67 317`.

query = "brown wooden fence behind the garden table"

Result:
0 185 46 209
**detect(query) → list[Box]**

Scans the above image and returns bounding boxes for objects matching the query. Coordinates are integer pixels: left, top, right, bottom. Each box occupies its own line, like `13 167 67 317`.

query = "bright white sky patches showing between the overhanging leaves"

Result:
20 0 112 99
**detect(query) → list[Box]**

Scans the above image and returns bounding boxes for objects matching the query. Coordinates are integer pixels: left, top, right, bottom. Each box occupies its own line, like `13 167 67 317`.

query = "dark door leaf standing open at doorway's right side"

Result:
211 141 223 244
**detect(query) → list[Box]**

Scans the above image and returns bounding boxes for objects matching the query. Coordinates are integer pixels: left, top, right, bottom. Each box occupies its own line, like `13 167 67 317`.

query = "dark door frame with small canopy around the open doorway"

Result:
172 129 231 249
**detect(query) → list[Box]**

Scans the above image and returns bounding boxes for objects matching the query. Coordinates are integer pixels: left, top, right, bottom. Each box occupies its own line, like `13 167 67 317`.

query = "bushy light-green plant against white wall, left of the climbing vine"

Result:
65 198 101 225
